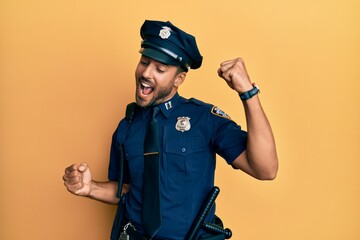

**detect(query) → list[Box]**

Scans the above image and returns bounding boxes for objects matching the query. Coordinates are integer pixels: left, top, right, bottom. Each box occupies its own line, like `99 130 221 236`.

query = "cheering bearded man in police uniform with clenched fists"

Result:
63 21 278 240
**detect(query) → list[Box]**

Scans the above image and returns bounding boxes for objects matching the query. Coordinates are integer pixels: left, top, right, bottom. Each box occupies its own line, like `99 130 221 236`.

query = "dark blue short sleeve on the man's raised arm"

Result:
209 109 247 164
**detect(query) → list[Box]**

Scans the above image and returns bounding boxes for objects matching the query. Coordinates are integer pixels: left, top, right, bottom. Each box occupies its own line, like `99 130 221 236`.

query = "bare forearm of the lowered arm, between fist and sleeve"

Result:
87 180 119 204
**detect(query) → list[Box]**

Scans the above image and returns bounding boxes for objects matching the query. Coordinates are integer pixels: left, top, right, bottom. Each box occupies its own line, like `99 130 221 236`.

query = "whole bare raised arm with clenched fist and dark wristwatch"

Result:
218 58 278 180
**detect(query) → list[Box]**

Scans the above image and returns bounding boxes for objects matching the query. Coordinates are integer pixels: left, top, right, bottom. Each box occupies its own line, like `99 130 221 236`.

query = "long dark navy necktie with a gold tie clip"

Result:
142 107 161 237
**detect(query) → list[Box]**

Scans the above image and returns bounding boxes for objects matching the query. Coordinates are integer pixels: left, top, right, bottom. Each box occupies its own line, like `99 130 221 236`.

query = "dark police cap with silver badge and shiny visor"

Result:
140 20 203 70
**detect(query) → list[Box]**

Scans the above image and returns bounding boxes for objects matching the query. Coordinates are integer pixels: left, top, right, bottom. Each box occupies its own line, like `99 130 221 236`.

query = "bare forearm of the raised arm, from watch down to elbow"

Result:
243 95 278 179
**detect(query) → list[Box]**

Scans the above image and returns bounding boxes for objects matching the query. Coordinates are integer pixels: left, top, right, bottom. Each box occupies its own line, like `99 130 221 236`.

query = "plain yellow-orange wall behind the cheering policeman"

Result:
0 0 360 240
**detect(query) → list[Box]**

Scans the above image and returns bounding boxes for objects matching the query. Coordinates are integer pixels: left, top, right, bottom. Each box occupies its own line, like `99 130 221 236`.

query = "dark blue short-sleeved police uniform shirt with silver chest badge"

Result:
108 94 247 240
